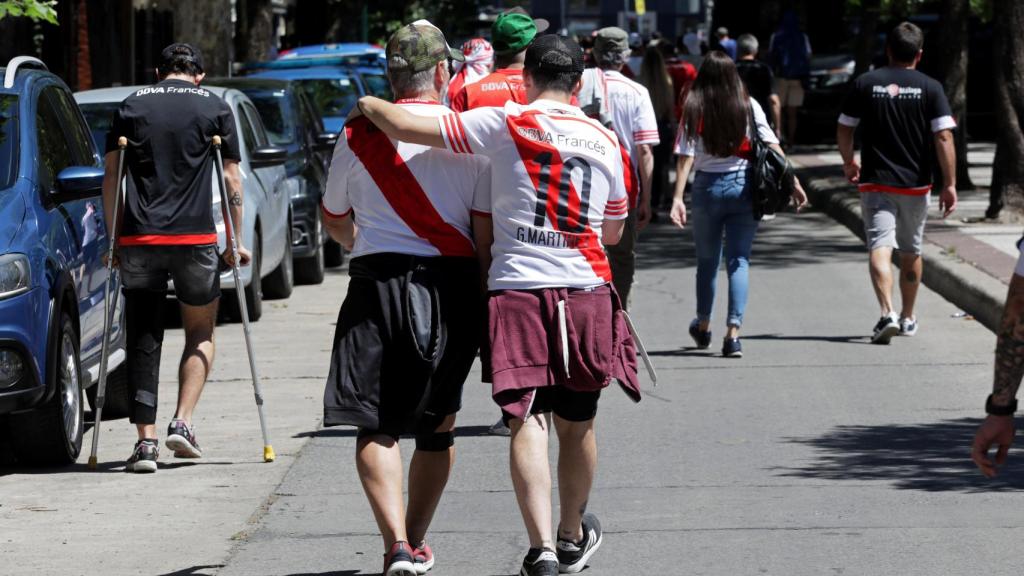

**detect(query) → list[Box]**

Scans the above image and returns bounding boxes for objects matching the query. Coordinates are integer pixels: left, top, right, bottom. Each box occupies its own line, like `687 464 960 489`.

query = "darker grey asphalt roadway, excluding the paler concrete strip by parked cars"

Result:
217 210 1024 576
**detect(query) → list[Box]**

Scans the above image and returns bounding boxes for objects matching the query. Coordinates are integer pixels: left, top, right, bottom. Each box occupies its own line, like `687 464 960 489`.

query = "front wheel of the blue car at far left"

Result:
9 315 85 465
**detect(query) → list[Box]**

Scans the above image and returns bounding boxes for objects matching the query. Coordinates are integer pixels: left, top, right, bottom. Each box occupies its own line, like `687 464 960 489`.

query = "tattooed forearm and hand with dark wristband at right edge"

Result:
971 272 1024 478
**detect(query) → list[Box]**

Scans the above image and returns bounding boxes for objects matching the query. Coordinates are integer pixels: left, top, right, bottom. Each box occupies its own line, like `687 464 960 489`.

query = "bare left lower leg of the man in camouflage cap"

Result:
355 435 409 551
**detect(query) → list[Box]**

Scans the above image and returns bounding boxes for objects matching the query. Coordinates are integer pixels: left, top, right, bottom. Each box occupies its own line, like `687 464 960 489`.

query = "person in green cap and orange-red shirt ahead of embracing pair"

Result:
452 7 550 112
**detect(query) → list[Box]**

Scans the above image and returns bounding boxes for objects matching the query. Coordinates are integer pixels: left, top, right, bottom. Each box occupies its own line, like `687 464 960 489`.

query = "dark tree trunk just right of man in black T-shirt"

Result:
932 0 974 190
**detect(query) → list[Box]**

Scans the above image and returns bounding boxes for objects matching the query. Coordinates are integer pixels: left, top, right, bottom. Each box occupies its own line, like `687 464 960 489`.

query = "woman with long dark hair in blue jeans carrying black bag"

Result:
671 50 807 358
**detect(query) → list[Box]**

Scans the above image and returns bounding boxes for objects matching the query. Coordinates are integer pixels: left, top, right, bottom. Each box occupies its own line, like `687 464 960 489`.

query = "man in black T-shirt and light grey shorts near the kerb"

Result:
837 23 956 344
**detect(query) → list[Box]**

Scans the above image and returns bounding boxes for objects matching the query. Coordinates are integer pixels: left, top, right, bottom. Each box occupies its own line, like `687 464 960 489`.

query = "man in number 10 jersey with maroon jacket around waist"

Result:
359 35 640 576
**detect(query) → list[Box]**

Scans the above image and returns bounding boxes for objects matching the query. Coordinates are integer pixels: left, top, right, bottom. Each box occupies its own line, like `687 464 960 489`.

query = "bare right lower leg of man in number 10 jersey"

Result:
555 416 597 542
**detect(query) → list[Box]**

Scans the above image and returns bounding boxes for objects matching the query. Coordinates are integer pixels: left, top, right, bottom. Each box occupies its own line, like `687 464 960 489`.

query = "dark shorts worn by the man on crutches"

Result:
118 244 220 306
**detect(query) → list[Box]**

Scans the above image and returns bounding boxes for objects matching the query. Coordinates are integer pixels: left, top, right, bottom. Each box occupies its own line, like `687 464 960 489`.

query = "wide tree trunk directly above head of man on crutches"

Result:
163 0 232 76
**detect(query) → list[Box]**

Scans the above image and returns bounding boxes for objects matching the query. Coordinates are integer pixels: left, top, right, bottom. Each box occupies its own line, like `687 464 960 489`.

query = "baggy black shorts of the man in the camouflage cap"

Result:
324 253 483 437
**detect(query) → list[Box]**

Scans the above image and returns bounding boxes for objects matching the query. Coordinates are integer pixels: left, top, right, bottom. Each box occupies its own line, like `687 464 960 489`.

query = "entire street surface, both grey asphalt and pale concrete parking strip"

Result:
0 207 1024 576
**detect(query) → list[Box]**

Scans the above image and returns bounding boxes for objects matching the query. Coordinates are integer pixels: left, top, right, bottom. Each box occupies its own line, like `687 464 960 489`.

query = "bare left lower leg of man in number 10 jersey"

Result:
509 414 555 549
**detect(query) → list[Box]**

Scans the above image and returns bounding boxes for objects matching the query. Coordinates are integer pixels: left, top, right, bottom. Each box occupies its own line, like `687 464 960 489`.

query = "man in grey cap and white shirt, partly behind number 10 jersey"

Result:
580 27 660 308
